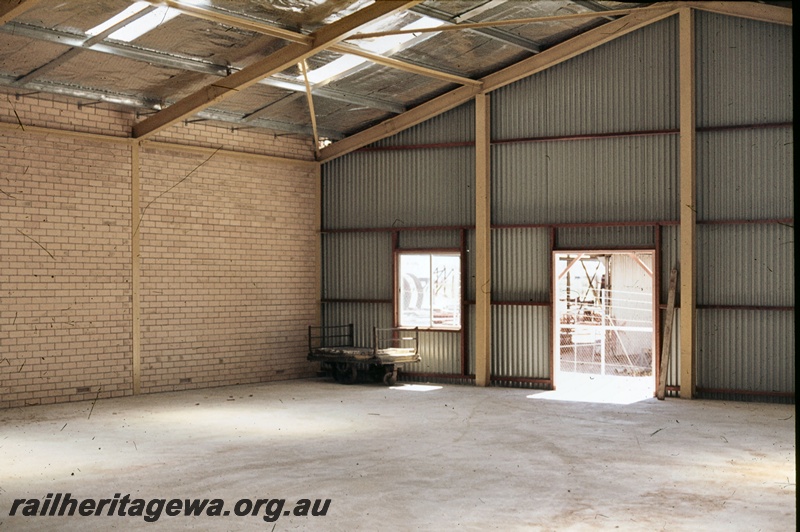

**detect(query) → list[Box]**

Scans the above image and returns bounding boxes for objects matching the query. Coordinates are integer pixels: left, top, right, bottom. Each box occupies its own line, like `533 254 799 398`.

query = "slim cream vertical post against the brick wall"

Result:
131 141 142 395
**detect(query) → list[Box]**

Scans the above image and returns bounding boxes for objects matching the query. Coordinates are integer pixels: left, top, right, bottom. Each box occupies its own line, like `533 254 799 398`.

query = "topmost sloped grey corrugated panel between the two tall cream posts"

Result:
492 17 678 141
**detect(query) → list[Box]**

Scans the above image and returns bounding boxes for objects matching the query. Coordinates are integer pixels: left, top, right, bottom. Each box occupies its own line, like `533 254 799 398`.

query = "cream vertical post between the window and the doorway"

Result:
475 94 492 386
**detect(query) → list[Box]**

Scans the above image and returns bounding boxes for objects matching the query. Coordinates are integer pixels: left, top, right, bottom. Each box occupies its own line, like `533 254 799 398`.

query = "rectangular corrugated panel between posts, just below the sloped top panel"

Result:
492 135 678 224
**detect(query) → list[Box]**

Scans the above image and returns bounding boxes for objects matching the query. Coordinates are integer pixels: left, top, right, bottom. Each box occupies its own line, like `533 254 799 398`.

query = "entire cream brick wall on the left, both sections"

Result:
0 90 319 408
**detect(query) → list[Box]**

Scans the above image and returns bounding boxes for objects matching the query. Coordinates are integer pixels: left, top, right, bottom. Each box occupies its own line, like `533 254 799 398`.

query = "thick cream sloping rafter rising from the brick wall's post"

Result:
133 0 421 138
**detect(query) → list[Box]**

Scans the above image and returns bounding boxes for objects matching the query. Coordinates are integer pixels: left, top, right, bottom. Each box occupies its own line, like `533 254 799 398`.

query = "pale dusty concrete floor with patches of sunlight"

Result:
0 379 796 531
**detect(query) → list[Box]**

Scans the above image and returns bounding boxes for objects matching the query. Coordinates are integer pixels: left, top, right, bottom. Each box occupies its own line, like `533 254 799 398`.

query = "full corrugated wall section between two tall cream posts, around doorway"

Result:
484 19 679 390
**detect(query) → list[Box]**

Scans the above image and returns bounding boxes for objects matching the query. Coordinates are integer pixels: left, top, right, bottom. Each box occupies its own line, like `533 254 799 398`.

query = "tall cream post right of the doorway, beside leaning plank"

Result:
678 8 697 399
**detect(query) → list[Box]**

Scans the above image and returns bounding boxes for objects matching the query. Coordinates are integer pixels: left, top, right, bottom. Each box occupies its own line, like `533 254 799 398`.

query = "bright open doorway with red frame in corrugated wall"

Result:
553 250 656 402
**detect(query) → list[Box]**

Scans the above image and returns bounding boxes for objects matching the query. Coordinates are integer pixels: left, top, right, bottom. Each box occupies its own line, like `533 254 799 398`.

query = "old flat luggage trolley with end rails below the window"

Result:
308 323 420 386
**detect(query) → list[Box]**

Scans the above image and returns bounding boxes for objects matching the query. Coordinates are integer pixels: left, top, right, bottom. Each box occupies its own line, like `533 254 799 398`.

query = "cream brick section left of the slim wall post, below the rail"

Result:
0 131 131 406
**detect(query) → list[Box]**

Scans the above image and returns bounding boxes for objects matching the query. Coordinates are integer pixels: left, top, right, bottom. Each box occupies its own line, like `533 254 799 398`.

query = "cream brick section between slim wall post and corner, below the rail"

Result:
140 148 317 391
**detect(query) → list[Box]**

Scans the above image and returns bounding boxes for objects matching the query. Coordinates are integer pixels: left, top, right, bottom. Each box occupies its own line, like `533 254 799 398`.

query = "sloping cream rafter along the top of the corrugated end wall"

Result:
320 4 677 162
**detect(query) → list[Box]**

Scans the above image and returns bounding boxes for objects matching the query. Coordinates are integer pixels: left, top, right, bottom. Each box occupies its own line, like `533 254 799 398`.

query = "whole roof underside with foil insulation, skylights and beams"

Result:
0 0 791 158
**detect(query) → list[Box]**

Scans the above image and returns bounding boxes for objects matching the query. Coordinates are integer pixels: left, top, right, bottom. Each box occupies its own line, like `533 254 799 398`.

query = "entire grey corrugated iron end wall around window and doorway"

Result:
323 12 794 400
